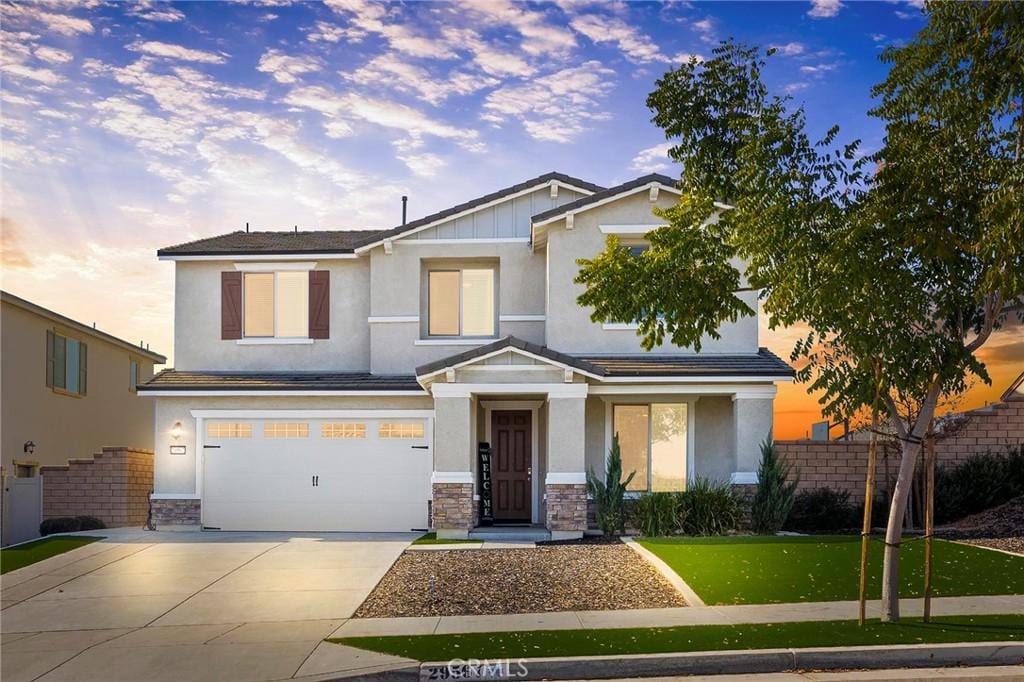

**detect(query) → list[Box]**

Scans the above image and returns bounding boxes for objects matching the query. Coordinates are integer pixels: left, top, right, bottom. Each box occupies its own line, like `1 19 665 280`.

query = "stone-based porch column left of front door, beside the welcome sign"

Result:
431 391 475 539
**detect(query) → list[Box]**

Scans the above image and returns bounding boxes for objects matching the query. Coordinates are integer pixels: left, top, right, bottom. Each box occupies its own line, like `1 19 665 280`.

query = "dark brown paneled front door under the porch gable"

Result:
490 410 534 522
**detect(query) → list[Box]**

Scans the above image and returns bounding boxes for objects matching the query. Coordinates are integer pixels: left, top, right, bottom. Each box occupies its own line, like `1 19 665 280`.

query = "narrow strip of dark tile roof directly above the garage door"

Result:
139 370 423 392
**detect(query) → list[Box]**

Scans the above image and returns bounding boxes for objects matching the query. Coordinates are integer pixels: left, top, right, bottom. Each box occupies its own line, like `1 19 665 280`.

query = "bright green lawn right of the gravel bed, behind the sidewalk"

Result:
637 536 1024 604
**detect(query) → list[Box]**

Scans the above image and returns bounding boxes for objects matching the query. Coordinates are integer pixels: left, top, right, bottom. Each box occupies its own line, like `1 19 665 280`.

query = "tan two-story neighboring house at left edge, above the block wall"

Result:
0 292 167 477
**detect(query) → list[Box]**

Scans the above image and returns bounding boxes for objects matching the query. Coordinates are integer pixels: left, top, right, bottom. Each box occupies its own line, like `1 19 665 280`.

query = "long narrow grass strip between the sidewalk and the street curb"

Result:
329 614 1024 660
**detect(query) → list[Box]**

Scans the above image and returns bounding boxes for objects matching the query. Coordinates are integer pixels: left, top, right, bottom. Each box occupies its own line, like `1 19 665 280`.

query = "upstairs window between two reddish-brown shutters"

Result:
243 271 309 339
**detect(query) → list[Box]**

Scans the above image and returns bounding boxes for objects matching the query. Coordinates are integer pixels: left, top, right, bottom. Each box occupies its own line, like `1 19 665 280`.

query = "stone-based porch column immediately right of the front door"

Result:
544 384 587 540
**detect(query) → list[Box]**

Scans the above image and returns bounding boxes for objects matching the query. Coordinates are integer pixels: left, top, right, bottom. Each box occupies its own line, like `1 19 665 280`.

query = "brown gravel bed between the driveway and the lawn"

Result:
355 543 686 619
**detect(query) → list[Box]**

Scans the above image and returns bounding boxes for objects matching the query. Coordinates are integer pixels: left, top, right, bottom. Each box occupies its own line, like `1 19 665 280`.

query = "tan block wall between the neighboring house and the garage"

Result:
40 447 153 528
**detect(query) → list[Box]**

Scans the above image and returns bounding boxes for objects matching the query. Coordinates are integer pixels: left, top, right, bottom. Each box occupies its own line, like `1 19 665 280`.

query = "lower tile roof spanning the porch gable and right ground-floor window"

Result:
416 336 795 378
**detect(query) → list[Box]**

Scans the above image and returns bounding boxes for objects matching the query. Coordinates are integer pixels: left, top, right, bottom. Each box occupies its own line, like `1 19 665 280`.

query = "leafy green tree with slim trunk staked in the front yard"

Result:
577 2 1024 621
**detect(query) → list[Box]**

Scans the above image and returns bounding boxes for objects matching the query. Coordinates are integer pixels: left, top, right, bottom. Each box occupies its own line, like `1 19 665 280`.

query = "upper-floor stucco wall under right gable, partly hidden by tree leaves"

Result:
546 191 758 354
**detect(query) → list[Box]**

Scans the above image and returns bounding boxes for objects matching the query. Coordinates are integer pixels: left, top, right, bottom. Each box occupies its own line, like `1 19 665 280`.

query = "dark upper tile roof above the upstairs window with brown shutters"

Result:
157 229 383 256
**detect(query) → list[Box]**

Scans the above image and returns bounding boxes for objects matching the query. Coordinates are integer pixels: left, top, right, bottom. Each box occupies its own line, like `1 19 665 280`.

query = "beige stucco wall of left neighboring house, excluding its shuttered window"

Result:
0 301 154 471
